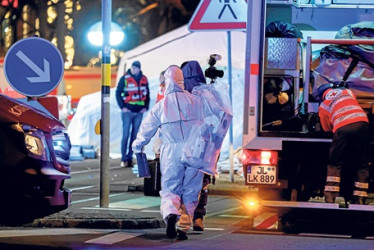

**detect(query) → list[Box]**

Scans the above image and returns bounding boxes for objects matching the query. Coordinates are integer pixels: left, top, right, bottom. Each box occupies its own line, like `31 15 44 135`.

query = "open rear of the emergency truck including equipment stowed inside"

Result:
242 1 374 218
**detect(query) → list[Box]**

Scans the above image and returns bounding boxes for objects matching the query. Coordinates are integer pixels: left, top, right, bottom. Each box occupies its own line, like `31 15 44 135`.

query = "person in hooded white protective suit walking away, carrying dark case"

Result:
132 65 204 240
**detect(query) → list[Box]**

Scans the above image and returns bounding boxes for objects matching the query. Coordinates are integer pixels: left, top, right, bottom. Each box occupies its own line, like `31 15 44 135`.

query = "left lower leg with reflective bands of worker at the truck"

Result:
324 165 341 203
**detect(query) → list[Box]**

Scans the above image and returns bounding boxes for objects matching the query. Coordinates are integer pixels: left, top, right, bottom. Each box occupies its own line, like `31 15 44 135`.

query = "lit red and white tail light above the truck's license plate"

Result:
241 149 278 165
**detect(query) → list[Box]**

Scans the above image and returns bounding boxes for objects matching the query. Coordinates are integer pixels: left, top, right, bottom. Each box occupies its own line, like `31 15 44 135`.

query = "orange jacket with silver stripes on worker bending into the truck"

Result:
318 88 369 132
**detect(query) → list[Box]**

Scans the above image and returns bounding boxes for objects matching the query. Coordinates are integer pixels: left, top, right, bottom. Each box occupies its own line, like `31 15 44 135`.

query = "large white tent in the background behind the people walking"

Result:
68 25 246 160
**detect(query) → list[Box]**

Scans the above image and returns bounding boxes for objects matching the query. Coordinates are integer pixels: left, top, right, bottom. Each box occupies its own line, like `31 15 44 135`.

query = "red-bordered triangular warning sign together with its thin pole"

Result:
188 0 247 182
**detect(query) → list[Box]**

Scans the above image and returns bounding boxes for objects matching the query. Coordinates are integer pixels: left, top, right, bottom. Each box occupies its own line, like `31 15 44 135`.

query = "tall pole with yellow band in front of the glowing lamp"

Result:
100 0 112 207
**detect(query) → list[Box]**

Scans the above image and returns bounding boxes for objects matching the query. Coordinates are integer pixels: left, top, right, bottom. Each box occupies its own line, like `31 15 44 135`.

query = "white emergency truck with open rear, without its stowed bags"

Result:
241 0 374 229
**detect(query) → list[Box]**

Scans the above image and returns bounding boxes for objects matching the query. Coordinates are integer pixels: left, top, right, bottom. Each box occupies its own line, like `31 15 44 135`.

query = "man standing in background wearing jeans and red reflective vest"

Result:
116 61 150 167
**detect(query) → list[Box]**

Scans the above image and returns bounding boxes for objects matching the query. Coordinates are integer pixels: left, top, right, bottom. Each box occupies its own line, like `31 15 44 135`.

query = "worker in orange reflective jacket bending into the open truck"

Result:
319 85 371 205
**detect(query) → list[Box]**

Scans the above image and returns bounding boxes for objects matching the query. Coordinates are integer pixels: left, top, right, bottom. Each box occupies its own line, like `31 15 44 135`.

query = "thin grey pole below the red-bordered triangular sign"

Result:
227 31 234 182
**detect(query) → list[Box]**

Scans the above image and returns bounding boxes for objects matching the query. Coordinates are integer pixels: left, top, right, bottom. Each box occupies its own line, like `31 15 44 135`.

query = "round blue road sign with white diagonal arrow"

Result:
4 37 64 97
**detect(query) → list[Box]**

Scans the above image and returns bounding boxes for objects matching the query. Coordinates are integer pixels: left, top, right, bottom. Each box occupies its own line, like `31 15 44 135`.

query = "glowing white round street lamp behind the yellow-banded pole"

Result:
87 22 125 46
